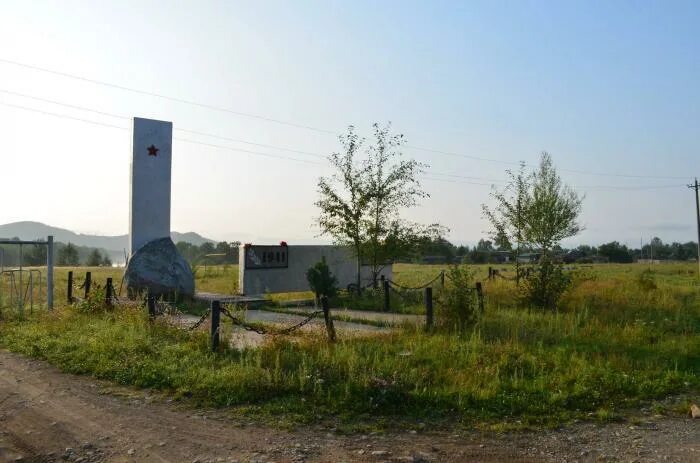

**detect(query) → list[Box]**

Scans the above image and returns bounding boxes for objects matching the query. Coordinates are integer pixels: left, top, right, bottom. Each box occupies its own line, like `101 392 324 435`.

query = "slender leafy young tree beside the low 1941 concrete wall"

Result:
315 124 445 288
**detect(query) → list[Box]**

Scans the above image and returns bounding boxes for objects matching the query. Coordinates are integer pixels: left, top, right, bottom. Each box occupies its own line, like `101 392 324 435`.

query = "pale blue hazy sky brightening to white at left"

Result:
0 0 700 245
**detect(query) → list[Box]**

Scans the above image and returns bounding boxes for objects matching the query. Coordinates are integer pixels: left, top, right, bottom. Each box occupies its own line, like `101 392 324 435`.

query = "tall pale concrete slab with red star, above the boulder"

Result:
129 117 173 255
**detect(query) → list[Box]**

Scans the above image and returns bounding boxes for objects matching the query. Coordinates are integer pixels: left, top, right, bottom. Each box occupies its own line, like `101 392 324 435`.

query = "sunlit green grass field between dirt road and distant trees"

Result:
0 264 700 427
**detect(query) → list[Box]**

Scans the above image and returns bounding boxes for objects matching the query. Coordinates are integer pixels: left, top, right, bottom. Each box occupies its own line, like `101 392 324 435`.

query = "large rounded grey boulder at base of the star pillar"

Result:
124 238 194 299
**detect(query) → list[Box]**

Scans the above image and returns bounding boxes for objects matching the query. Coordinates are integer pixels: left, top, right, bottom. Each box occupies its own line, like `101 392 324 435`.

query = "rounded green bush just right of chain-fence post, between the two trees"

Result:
439 265 479 331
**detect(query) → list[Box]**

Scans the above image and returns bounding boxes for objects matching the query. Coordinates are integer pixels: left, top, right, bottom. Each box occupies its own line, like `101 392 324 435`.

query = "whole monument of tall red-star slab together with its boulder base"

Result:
125 117 194 297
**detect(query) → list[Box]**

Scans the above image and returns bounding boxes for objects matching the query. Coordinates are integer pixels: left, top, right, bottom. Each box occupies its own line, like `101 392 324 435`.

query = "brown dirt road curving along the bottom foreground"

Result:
0 351 700 463
